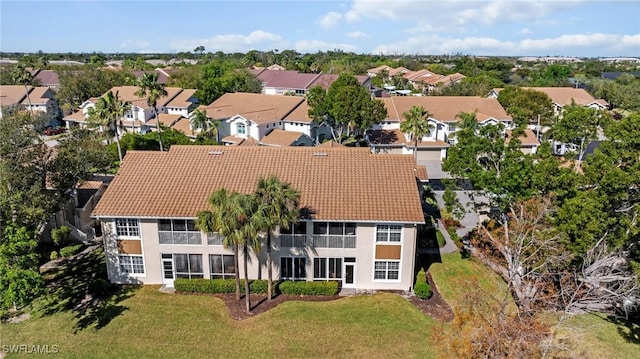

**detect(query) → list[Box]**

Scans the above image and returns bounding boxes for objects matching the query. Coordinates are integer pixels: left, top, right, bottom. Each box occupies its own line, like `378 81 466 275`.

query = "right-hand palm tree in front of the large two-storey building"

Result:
256 176 300 300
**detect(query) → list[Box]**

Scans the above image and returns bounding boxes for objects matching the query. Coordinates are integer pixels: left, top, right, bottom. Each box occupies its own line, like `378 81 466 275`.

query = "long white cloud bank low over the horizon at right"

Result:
372 33 640 56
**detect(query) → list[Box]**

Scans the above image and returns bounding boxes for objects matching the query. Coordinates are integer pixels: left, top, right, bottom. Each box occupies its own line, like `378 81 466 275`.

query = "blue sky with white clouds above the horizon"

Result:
0 0 640 57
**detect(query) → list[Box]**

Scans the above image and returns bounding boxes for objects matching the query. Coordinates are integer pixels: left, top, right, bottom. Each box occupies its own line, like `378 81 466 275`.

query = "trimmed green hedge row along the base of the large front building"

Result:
173 278 339 295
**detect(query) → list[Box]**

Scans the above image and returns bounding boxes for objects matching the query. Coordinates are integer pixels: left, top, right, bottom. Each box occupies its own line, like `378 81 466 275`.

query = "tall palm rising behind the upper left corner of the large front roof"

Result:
89 91 131 163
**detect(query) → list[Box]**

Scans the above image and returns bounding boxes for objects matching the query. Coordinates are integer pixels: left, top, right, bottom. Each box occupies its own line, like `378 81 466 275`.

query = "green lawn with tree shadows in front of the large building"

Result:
0 249 435 358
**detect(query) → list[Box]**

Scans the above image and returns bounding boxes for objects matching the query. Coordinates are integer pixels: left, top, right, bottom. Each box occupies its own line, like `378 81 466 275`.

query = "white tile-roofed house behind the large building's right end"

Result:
376 96 513 161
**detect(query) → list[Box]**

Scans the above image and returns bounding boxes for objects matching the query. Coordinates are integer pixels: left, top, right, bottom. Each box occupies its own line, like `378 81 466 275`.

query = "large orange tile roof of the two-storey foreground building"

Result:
93 145 424 223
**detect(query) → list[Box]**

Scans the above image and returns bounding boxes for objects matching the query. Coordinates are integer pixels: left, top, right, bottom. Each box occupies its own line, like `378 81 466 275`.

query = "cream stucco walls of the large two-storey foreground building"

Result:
101 218 416 291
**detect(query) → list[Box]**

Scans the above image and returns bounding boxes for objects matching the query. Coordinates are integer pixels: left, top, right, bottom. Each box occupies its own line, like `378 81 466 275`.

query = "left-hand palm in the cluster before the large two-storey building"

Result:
196 188 251 300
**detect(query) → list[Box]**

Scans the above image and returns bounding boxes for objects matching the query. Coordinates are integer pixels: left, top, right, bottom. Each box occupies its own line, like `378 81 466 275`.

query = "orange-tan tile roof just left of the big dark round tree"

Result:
205 92 304 124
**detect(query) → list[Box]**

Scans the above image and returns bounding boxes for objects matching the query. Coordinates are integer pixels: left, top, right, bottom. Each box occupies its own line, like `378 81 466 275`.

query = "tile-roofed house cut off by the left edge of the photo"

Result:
0 85 60 118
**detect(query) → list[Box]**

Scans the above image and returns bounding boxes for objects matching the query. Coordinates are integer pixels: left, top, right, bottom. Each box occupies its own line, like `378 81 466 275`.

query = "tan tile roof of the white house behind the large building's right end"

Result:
380 96 512 122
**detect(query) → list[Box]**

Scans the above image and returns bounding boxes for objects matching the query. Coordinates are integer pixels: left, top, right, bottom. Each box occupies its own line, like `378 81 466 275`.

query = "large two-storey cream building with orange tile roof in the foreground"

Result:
93 145 425 291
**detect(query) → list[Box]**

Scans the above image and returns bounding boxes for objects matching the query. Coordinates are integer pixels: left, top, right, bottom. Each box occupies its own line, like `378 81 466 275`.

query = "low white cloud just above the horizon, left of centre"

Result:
170 30 289 52
